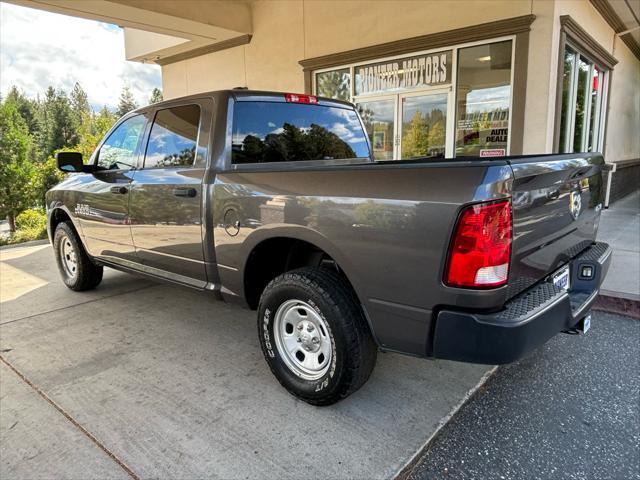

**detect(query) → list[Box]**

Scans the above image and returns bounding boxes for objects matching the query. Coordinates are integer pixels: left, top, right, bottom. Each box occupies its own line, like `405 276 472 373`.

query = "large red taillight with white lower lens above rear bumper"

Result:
445 200 511 288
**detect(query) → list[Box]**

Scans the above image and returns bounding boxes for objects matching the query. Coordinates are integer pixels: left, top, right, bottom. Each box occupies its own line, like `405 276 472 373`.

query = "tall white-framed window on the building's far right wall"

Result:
559 45 605 153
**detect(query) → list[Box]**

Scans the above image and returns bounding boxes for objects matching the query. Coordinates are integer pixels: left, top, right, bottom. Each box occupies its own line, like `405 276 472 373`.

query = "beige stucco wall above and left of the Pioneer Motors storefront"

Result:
162 0 531 98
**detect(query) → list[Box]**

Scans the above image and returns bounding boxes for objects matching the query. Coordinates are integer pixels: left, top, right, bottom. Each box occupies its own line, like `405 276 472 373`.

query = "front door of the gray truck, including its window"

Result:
75 115 147 262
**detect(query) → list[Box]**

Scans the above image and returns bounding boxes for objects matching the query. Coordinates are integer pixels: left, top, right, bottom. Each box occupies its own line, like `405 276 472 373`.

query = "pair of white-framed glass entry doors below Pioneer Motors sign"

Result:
356 89 453 161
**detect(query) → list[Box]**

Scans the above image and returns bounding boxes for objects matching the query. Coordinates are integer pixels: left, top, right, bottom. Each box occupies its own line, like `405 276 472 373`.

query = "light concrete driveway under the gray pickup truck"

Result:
0 245 488 479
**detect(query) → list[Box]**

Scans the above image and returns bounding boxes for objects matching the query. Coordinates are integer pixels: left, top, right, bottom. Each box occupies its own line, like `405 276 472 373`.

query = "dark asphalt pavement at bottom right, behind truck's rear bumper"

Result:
408 312 640 480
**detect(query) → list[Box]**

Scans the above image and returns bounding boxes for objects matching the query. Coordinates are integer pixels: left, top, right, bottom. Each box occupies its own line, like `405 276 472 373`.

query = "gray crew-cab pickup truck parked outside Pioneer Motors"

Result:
47 90 611 405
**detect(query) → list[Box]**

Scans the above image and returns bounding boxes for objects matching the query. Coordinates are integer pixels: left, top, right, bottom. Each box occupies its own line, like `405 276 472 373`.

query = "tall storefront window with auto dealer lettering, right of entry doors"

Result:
456 40 511 157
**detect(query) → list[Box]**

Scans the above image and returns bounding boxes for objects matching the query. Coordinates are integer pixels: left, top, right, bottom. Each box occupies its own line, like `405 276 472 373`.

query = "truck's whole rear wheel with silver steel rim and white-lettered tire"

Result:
258 267 377 405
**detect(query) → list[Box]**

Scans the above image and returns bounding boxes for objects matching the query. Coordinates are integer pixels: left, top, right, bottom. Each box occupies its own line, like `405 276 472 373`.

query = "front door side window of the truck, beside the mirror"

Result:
98 115 146 170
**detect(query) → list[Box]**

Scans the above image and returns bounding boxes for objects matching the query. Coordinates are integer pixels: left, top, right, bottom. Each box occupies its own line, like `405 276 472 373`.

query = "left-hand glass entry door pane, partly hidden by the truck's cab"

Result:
358 99 396 160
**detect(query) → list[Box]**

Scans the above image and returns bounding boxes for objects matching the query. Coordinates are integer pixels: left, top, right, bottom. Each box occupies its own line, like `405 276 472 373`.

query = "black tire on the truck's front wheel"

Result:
53 222 103 292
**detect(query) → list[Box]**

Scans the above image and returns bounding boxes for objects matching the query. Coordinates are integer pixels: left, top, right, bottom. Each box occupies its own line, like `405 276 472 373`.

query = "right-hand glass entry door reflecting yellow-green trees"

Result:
399 90 449 159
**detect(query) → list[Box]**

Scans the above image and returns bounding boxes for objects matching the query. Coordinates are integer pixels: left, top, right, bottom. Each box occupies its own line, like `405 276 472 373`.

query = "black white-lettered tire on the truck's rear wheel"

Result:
258 267 377 406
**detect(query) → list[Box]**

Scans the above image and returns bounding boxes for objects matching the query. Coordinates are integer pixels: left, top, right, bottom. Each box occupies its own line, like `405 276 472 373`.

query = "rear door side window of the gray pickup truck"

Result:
144 105 200 168
